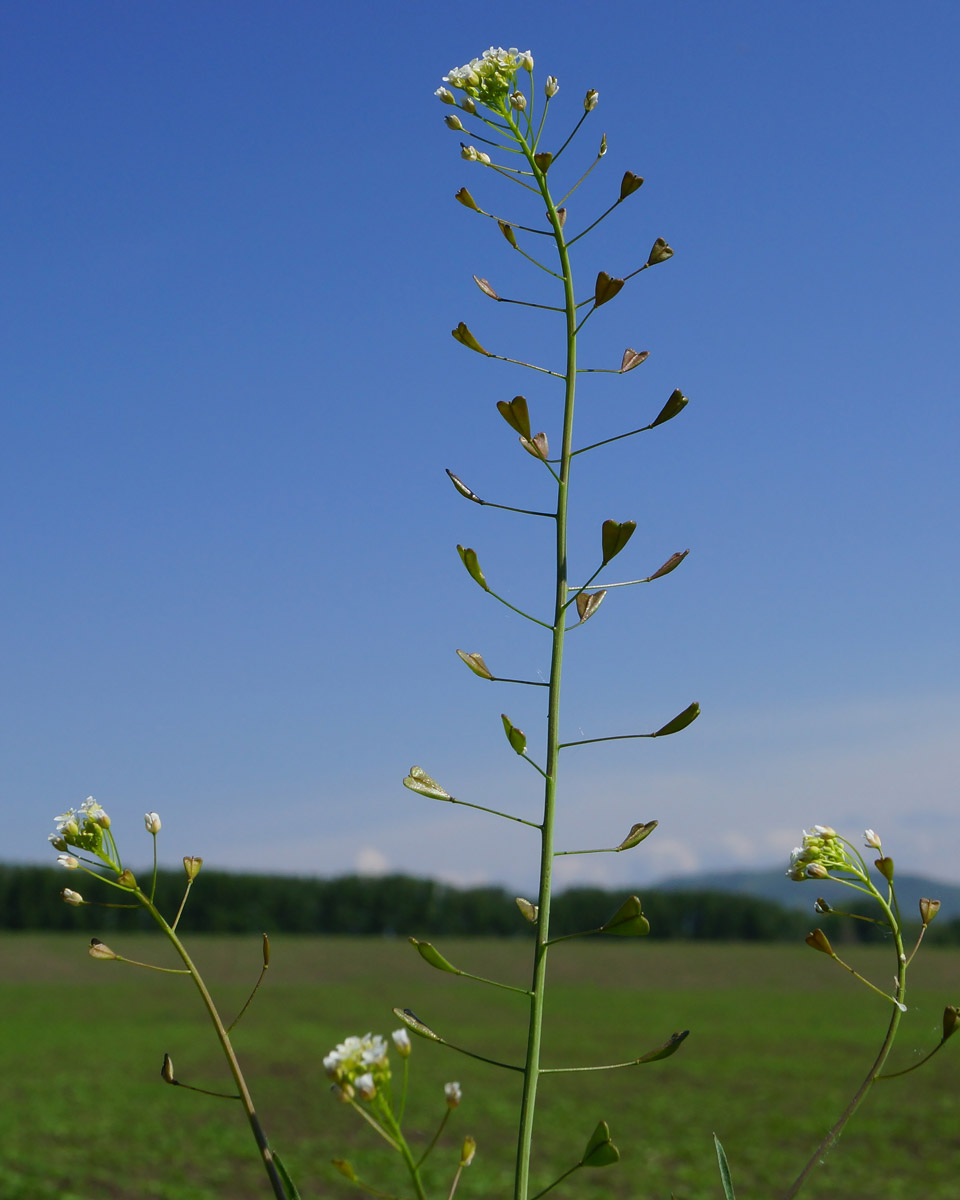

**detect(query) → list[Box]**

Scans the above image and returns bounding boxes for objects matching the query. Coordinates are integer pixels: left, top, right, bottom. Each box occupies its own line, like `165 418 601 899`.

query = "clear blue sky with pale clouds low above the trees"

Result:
0 0 960 887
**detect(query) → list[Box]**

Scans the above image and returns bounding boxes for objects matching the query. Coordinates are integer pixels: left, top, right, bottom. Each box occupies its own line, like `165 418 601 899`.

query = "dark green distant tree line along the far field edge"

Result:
0 864 960 944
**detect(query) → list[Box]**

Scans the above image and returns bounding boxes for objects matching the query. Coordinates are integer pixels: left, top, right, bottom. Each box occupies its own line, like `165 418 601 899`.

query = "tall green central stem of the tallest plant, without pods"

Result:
506 105 577 1200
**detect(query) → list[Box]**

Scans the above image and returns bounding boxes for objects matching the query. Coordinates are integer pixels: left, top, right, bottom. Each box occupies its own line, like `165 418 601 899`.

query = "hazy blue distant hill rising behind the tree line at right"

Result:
647 869 960 920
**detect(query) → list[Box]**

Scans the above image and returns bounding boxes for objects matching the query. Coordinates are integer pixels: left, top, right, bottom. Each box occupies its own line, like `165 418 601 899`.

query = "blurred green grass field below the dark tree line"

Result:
0 935 960 1200
